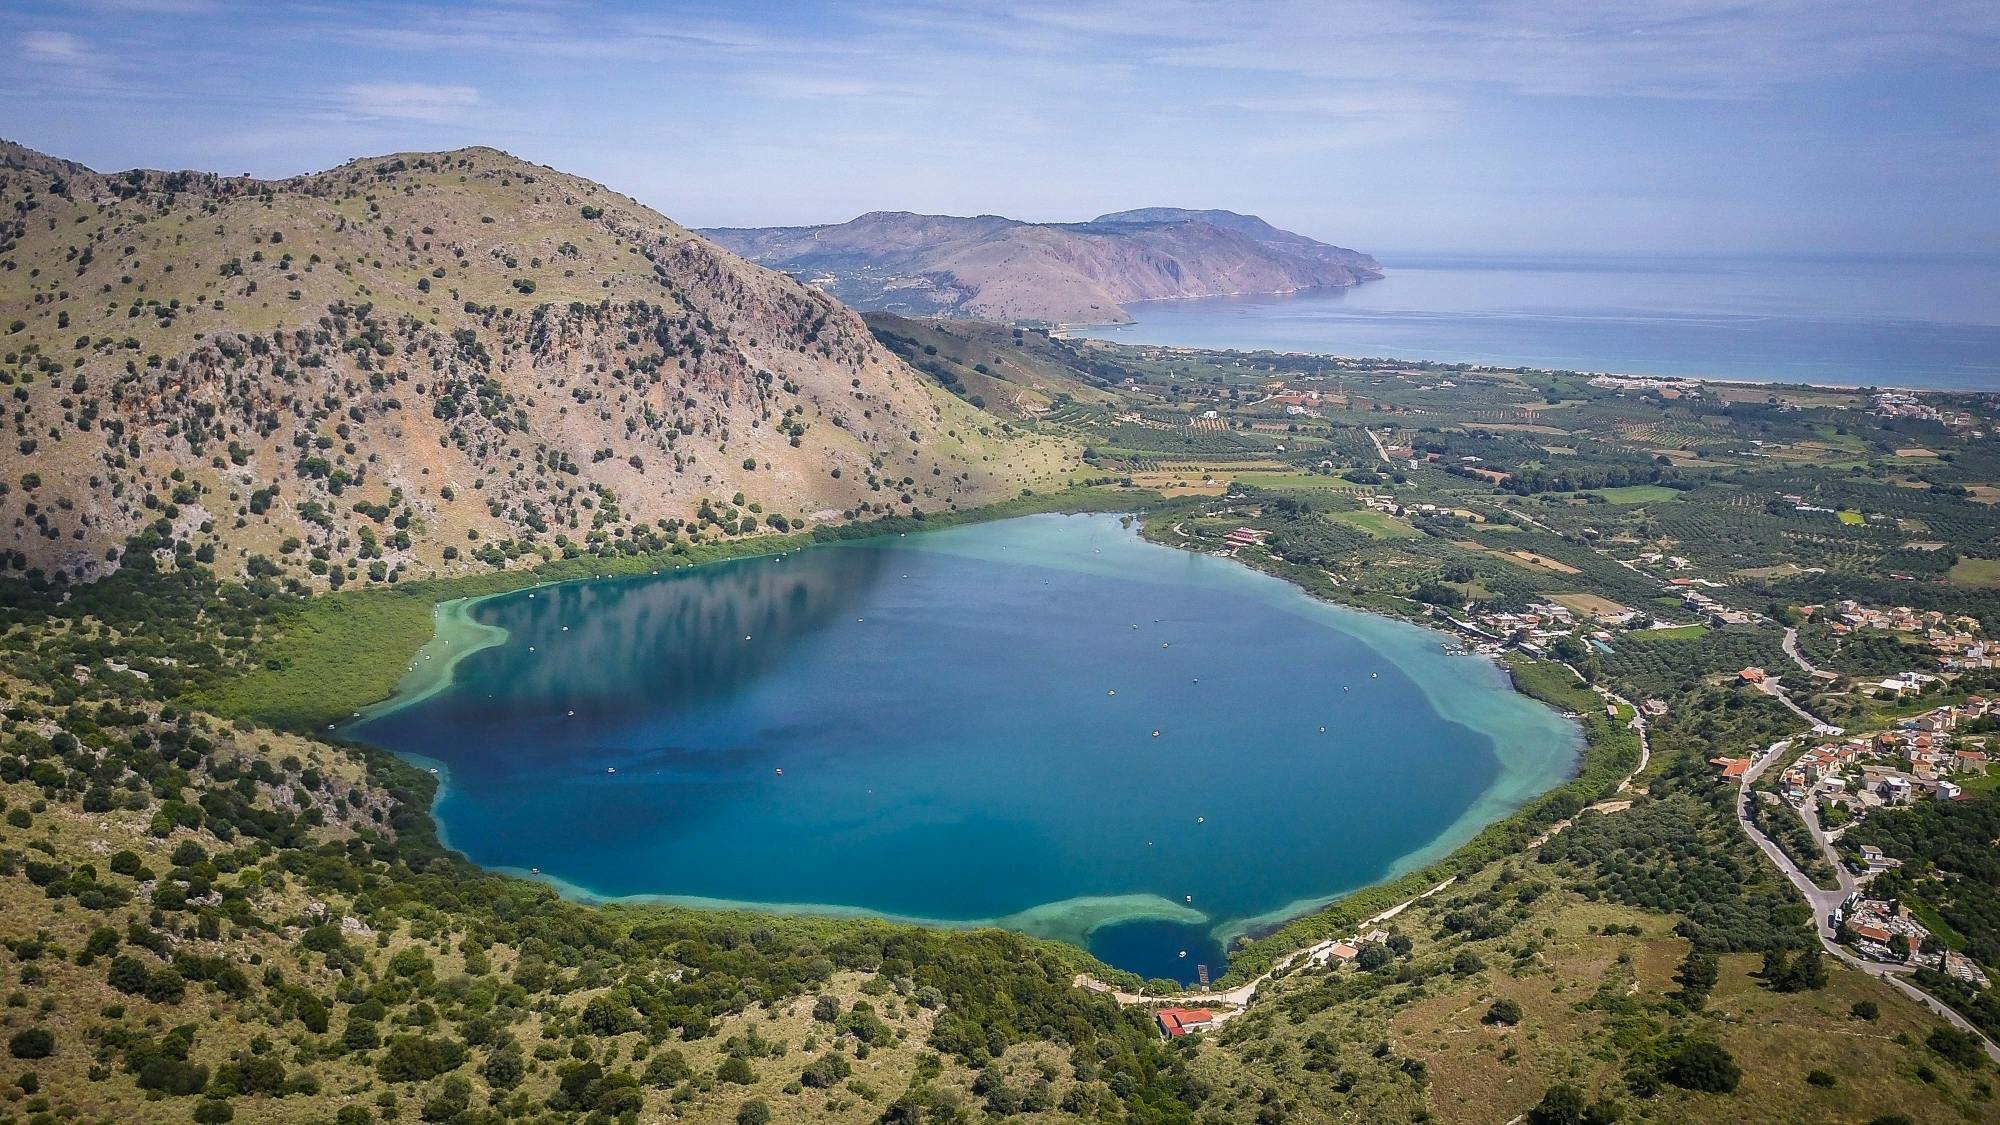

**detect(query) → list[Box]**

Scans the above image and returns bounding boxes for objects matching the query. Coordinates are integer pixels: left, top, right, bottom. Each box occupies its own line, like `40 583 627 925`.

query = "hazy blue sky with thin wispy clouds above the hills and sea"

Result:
0 0 2000 254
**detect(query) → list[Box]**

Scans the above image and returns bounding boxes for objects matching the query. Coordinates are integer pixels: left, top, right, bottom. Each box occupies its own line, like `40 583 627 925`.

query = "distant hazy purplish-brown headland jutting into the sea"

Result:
702 206 1382 324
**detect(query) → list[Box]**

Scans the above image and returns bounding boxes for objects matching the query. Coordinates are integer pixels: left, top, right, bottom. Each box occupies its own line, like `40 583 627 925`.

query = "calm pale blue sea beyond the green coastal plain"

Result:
1082 254 2000 390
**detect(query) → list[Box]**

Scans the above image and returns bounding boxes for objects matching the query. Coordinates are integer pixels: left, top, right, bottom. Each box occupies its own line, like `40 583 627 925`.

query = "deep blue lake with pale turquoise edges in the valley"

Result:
352 514 1580 979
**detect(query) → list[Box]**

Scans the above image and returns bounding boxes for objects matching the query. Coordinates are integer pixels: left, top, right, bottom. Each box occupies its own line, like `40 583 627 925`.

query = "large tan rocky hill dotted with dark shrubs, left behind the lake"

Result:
0 142 1058 587
